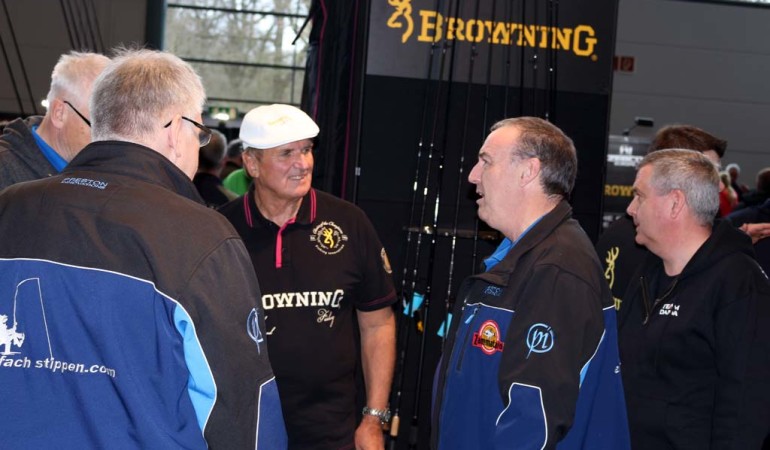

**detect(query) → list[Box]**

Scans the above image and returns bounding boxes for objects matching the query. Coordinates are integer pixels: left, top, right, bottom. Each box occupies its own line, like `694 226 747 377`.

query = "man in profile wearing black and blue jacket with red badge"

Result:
432 117 628 450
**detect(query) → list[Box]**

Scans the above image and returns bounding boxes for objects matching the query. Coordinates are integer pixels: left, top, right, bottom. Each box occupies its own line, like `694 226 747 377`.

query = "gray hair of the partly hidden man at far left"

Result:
46 52 110 104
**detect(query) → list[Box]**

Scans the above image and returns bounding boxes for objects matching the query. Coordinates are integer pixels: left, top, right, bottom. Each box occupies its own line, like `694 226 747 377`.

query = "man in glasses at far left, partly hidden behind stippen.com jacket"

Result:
0 52 110 189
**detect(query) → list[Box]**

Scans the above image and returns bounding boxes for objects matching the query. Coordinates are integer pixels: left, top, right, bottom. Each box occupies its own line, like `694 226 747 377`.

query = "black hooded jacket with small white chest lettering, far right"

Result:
619 221 770 450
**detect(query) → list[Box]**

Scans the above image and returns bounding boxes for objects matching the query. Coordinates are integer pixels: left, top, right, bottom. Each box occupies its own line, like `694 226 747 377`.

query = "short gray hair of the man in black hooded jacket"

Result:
639 149 719 226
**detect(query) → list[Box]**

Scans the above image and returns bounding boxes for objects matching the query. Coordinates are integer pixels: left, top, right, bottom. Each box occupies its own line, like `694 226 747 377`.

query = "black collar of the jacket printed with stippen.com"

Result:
62 141 203 203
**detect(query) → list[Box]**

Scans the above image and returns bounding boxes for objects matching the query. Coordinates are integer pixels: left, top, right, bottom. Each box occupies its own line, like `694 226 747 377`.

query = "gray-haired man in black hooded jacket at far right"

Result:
619 149 770 450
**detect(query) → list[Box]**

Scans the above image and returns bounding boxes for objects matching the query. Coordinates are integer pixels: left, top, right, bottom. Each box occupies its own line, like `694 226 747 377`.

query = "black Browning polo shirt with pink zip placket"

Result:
220 186 396 449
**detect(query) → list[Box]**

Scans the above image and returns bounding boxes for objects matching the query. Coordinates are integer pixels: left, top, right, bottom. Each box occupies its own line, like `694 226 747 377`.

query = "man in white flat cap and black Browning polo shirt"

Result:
220 105 396 449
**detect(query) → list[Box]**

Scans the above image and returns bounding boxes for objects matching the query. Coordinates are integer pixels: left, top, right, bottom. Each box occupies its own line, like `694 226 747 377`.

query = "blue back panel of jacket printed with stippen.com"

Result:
0 260 207 449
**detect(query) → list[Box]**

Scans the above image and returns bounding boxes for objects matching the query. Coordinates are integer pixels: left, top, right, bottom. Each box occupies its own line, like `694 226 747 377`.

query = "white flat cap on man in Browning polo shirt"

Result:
238 104 320 149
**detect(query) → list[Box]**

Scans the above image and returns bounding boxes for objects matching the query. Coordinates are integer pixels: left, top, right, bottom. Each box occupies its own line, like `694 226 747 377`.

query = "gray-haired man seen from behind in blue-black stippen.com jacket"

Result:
0 50 286 449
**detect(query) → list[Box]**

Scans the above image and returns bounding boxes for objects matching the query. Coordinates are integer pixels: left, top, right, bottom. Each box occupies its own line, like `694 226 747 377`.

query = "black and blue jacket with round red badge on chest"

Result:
432 201 629 449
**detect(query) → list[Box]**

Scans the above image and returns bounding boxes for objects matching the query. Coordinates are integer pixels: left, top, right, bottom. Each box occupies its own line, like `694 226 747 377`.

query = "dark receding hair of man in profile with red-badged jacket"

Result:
490 117 577 197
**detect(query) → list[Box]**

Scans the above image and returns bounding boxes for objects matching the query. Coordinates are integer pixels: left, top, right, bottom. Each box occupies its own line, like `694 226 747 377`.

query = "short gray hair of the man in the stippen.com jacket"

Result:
91 49 206 141
